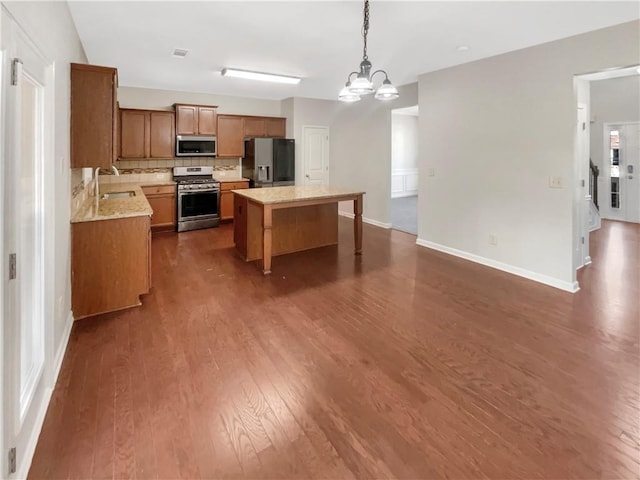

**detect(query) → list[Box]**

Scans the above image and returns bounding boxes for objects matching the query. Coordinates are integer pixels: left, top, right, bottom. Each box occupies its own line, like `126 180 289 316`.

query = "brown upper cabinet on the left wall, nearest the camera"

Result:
71 63 118 168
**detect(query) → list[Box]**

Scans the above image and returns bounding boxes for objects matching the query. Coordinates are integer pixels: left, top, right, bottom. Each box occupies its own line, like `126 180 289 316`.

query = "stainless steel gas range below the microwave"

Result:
173 167 220 232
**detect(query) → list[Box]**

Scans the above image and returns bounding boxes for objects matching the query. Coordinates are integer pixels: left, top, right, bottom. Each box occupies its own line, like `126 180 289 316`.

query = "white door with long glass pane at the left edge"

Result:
2 11 53 478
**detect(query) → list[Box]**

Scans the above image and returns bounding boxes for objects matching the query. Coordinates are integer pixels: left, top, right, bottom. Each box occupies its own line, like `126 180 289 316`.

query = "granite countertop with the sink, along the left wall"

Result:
71 183 155 223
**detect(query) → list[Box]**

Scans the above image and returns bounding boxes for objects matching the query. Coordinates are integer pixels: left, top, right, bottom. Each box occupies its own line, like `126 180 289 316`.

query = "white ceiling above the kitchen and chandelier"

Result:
69 0 640 100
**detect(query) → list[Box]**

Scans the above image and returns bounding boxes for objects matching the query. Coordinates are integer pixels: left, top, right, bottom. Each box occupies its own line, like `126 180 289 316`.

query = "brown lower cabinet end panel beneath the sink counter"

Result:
71 216 151 320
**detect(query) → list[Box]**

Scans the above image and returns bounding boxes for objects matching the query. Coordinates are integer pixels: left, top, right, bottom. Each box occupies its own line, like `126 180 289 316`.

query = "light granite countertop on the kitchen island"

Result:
232 185 365 204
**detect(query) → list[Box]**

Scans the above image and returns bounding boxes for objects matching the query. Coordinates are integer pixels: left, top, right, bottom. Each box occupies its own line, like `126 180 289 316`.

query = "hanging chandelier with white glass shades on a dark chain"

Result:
338 0 400 102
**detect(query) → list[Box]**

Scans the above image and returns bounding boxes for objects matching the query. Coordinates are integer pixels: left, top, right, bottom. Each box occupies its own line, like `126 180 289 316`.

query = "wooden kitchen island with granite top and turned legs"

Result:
233 185 365 275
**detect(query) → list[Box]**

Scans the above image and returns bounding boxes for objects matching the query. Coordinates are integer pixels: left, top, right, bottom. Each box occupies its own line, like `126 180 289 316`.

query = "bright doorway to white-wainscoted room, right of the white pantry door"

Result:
391 105 419 235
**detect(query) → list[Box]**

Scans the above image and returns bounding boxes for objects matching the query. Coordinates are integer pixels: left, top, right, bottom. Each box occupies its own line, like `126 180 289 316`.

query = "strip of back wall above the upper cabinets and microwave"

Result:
118 85 281 117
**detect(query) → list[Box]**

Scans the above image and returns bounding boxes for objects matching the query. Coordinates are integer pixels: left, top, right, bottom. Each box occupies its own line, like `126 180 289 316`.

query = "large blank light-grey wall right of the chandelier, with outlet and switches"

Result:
418 21 640 289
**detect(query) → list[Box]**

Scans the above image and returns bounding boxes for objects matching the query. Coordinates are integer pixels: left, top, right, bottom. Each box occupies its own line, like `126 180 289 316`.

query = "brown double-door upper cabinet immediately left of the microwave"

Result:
120 108 176 159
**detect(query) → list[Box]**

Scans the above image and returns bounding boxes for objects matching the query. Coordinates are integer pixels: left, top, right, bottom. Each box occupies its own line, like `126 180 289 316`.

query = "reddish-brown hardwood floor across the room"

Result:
29 218 640 479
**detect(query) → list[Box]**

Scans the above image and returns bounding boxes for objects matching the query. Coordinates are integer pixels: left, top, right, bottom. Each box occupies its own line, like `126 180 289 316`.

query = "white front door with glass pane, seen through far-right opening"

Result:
604 123 640 223
